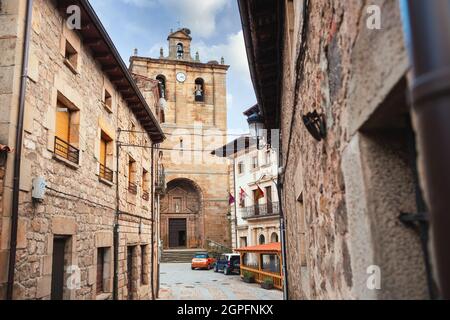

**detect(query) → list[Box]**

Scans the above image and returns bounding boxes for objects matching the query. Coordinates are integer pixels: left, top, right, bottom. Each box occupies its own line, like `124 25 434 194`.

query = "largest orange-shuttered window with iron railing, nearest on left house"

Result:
54 95 80 164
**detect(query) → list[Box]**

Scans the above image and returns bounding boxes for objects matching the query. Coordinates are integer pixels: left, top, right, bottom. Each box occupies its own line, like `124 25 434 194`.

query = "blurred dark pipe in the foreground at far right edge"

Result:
402 0 450 299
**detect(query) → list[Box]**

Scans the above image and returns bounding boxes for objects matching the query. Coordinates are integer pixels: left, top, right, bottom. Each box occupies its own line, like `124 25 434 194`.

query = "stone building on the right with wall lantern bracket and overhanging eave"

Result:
239 0 436 299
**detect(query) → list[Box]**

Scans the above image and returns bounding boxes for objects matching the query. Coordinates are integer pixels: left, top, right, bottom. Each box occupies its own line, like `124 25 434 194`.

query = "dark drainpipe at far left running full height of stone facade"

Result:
6 0 33 300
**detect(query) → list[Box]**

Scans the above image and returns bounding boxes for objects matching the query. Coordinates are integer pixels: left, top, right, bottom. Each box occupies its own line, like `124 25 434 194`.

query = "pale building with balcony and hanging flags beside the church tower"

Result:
214 107 280 249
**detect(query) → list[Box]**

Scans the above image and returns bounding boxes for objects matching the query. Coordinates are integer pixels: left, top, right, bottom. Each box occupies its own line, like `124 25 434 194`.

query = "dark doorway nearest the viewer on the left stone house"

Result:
51 238 66 300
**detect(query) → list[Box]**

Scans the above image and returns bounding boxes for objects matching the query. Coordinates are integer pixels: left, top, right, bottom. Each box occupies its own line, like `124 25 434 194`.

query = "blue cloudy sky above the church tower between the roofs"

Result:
90 0 256 133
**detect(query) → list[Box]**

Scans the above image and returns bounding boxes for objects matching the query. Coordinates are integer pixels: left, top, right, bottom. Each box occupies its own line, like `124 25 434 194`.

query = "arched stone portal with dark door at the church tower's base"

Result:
161 178 205 249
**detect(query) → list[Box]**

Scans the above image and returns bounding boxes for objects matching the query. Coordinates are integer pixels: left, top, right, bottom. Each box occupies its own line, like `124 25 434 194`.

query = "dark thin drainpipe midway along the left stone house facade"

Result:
113 128 121 300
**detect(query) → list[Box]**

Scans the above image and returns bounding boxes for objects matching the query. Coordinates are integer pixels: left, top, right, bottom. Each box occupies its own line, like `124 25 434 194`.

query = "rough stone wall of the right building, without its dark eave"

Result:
281 0 427 299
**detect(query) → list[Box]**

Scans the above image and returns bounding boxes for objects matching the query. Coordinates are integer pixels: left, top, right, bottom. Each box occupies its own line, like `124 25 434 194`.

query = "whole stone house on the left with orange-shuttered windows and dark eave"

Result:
0 0 164 299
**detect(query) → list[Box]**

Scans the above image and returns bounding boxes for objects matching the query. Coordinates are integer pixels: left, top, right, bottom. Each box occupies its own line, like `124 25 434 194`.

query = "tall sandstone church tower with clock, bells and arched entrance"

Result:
130 28 231 249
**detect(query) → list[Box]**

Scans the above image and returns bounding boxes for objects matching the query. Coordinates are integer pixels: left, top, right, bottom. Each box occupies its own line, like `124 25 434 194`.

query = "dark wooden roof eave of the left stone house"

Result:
57 0 166 143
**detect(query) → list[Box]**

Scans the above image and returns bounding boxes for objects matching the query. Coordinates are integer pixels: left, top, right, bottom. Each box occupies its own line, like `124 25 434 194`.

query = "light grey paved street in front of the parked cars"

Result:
159 263 283 300
